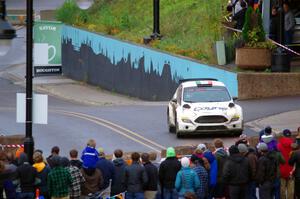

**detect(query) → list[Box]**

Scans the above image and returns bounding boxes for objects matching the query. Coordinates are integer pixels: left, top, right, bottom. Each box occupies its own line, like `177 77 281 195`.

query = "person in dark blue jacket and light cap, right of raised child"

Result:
96 148 115 198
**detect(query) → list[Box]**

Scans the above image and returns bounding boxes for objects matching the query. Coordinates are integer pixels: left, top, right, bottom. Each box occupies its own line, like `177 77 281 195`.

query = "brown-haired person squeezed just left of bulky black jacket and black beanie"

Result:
213 139 228 198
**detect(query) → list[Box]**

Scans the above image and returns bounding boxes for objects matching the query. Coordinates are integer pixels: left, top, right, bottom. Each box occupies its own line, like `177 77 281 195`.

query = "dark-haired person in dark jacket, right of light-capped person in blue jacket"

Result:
111 149 126 196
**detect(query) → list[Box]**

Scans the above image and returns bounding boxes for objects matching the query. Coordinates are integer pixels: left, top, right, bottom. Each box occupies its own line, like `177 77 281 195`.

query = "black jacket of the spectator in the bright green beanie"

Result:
159 157 181 189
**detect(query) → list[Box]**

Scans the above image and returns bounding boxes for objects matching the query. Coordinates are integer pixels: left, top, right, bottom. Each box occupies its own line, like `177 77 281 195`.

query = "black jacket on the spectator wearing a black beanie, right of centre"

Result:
223 154 251 186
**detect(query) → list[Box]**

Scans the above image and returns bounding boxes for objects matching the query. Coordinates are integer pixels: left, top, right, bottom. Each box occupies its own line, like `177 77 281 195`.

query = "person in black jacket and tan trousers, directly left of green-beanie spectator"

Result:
142 153 158 199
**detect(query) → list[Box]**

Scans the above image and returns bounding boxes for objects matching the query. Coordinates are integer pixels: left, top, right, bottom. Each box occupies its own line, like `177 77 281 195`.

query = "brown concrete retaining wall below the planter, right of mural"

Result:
238 73 300 100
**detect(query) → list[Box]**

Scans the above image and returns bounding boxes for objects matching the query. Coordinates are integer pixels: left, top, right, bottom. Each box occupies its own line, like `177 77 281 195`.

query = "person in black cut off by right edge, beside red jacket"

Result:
289 145 300 198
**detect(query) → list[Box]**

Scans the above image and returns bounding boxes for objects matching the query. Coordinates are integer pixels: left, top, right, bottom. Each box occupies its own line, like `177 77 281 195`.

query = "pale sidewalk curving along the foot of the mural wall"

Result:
0 64 167 106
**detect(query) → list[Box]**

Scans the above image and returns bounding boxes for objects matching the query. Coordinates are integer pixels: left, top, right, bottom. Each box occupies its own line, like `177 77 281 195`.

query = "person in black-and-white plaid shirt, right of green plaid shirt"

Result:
61 157 85 199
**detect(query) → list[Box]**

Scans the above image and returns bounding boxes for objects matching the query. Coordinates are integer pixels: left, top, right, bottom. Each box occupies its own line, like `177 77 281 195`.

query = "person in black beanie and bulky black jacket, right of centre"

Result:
223 145 251 199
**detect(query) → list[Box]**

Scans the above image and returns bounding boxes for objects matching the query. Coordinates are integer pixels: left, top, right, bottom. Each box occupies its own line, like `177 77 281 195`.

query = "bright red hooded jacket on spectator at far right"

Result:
277 137 294 178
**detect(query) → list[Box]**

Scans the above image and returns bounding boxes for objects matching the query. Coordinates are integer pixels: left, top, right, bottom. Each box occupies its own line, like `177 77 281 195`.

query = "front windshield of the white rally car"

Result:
183 86 231 103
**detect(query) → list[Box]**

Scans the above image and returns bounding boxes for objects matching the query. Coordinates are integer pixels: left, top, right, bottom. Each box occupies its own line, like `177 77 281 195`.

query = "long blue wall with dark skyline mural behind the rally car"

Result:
62 26 238 100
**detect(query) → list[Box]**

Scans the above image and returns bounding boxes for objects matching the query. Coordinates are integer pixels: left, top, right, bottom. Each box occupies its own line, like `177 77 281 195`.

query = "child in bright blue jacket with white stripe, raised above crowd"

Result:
81 139 99 169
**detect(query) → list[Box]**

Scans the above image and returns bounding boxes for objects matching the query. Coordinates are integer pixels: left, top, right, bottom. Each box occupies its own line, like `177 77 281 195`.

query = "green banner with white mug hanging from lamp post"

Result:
33 21 62 76
